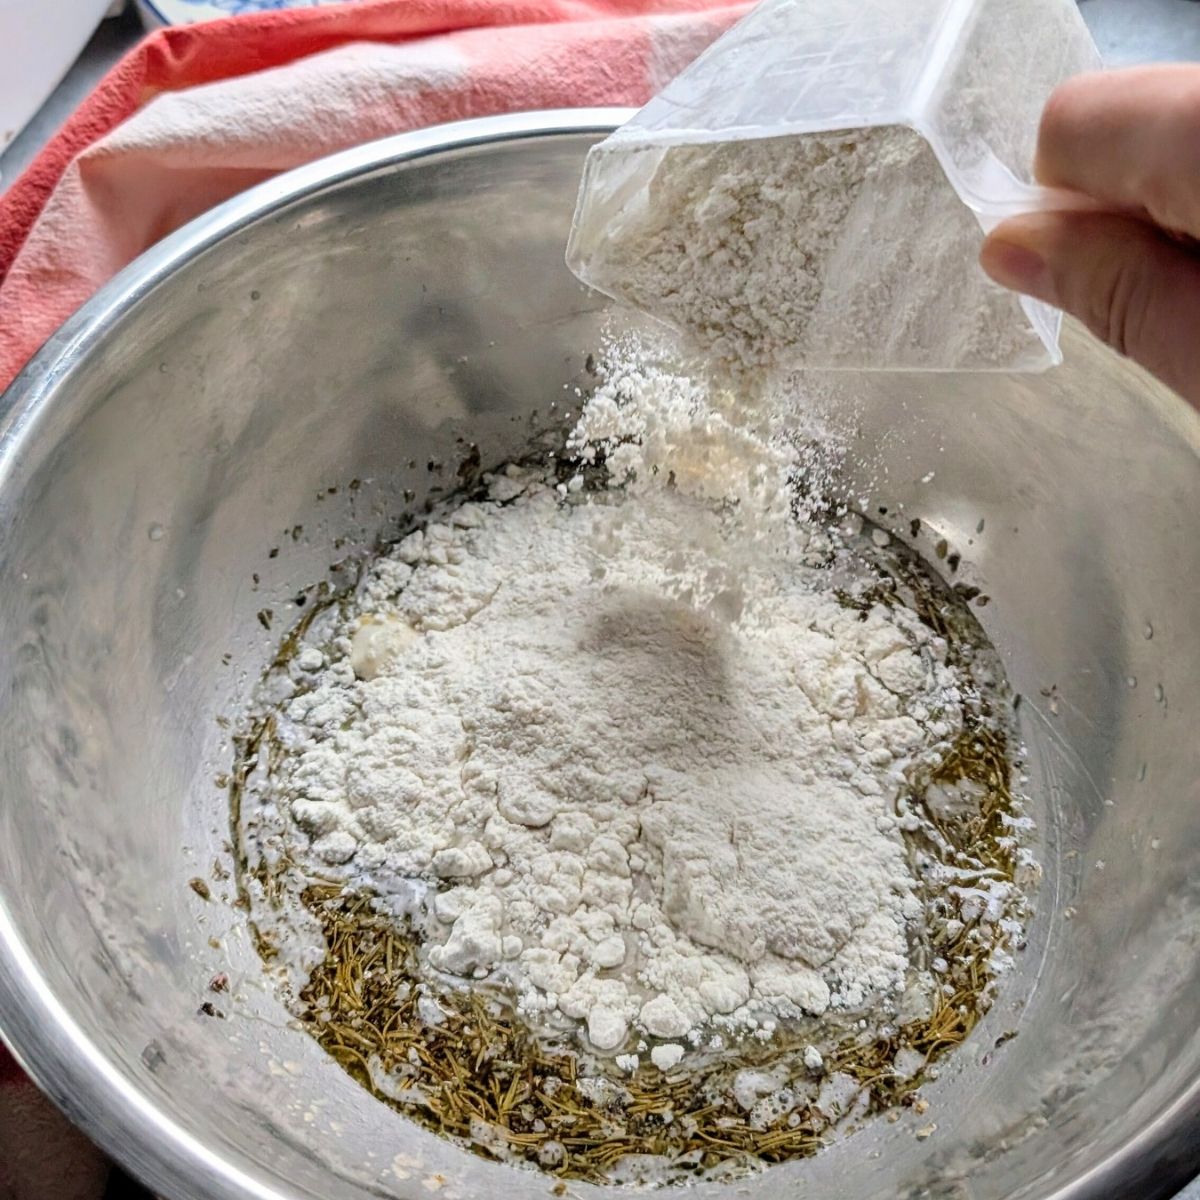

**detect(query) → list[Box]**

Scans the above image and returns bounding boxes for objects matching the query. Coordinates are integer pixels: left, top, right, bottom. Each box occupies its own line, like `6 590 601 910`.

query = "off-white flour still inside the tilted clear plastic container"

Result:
584 126 1042 373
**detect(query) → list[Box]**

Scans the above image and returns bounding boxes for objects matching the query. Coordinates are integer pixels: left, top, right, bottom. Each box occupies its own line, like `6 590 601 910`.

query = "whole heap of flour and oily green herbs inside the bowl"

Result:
234 347 1036 1182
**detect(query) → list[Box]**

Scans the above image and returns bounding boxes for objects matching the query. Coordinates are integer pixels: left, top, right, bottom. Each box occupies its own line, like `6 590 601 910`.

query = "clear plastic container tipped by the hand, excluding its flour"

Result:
568 0 1100 370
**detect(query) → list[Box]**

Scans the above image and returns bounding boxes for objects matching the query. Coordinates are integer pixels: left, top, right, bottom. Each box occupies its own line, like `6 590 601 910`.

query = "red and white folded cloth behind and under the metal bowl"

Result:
0 0 749 1200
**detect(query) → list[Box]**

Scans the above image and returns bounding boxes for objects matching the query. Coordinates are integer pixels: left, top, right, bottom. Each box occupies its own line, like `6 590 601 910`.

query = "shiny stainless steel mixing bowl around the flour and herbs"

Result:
0 112 1200 1200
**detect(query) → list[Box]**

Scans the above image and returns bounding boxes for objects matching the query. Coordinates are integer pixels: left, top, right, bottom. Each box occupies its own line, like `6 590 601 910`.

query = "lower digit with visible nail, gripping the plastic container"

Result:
979 212 1200 406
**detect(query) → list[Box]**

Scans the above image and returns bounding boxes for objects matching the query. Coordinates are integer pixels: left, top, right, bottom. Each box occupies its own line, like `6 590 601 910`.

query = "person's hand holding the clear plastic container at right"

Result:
980 65 1200 407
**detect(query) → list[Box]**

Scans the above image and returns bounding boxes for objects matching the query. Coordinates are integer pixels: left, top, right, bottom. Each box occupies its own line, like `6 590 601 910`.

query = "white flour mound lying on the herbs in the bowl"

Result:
272 384 961 1069
